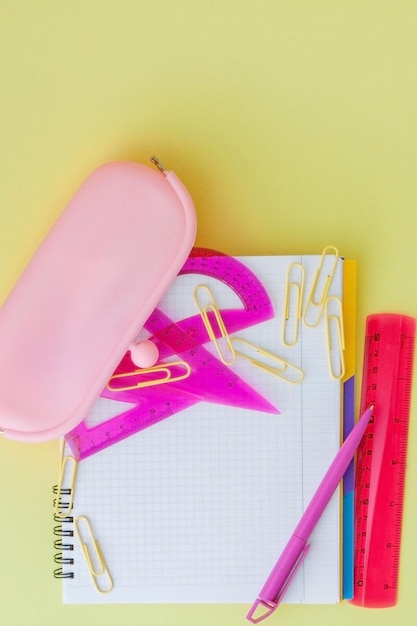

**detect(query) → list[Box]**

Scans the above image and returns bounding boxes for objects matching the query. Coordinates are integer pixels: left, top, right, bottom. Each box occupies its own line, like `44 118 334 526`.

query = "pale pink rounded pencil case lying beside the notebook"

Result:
0 162 196 442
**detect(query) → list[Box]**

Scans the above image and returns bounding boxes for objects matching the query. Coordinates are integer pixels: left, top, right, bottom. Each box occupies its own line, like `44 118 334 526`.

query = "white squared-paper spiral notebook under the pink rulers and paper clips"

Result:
55 255 353 604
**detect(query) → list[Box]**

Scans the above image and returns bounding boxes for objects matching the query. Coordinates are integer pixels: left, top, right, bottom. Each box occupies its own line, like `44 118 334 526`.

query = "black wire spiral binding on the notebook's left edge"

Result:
53 485 74 578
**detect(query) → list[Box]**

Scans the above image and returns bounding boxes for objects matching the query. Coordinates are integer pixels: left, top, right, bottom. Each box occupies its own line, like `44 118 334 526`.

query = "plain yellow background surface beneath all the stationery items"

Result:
0 0 417 626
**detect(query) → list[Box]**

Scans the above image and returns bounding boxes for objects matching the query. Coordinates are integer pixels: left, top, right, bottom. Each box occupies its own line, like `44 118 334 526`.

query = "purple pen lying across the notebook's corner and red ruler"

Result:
246 406 374 624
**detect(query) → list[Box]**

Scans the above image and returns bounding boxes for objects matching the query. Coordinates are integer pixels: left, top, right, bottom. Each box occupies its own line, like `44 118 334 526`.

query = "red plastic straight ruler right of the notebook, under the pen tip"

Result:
352 314 416 608
